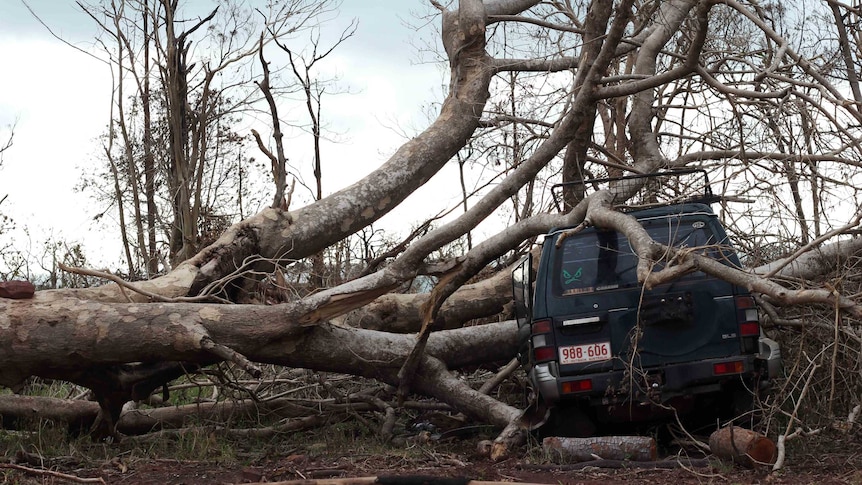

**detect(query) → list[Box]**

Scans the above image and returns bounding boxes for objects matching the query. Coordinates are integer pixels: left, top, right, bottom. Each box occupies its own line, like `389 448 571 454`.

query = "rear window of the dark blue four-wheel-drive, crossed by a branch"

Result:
553 219 721 296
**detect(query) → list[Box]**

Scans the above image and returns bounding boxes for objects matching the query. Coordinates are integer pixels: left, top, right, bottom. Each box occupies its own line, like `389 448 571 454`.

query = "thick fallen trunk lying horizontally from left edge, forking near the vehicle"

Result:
0 292 517 436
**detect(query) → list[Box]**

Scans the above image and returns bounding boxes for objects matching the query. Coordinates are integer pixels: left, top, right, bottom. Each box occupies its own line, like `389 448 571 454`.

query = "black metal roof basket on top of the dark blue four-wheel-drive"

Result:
551 168 721 211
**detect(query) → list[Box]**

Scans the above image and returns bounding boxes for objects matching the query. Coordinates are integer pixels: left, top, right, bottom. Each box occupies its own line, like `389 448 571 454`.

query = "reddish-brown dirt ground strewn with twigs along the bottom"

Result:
5 436 862 485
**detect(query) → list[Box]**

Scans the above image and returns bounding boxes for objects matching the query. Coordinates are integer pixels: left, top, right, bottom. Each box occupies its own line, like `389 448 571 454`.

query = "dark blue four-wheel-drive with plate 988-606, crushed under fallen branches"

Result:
513 170 781 436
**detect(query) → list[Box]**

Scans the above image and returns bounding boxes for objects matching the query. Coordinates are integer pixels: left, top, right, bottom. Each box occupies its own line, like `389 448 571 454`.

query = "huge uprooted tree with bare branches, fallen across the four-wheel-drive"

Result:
0 0 862 458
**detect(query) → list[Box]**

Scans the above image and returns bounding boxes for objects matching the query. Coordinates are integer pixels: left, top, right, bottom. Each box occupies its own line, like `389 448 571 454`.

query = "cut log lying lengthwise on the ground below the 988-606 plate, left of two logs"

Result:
542 436 658 463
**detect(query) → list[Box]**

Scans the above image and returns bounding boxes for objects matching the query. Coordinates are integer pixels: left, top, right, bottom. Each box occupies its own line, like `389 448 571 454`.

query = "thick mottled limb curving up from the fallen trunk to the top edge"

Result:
59 0 500 301
